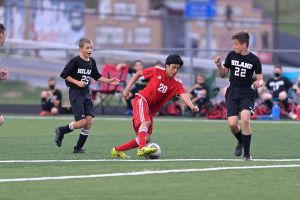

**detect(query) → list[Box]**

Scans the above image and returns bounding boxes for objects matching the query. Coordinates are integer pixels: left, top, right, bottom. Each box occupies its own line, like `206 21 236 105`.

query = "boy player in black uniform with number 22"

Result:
214 31 263 160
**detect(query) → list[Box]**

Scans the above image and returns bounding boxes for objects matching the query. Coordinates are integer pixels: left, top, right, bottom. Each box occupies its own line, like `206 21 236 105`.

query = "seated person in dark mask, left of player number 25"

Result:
39 77 62 116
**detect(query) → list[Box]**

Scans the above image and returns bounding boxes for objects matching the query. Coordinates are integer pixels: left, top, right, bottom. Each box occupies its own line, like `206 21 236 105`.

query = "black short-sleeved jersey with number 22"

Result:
224 51 262 87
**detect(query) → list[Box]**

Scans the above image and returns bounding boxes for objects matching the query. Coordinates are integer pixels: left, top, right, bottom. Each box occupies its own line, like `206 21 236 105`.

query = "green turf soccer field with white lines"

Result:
0 116 300 200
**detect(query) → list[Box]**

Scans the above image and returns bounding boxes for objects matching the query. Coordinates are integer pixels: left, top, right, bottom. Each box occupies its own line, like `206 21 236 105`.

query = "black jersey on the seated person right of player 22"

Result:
266 77 293 97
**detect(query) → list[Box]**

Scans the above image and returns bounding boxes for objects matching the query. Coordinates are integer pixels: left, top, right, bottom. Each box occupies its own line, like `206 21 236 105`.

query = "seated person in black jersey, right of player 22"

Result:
259 65 296 119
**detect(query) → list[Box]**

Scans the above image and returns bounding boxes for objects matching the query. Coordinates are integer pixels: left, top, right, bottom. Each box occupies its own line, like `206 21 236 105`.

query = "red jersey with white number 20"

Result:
139 66 185 115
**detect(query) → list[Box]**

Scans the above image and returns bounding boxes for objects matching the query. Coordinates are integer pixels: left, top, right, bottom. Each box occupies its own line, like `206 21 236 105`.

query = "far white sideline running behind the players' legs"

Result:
5 115 300 124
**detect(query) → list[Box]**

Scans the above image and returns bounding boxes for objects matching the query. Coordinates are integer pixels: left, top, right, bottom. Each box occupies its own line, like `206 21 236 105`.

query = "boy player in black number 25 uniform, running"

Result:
55 38 120 153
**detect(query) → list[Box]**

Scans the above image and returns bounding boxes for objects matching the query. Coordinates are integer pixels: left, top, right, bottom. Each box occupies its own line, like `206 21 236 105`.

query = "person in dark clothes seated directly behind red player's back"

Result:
125 60 147 115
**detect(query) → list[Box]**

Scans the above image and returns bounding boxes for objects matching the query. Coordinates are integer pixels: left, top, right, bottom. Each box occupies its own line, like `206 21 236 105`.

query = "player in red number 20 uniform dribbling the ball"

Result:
111 55 199 158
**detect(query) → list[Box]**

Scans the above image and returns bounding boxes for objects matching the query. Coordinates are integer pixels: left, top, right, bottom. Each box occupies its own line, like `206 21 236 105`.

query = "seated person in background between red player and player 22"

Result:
189 74 209 115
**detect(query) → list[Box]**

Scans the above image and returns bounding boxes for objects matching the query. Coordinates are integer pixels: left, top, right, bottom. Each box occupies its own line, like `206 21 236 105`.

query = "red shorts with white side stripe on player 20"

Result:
132 95 153 135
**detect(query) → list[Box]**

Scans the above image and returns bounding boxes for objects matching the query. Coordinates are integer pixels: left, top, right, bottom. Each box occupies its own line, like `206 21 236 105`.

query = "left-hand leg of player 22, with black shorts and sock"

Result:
225 87 243 156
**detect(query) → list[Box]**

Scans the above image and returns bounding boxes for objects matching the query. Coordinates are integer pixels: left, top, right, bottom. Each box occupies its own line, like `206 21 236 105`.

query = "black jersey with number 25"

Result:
60 55 102 89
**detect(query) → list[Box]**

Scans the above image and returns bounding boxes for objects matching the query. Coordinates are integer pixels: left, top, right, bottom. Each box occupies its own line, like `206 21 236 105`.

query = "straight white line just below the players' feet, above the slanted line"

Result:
0 158 300 164
